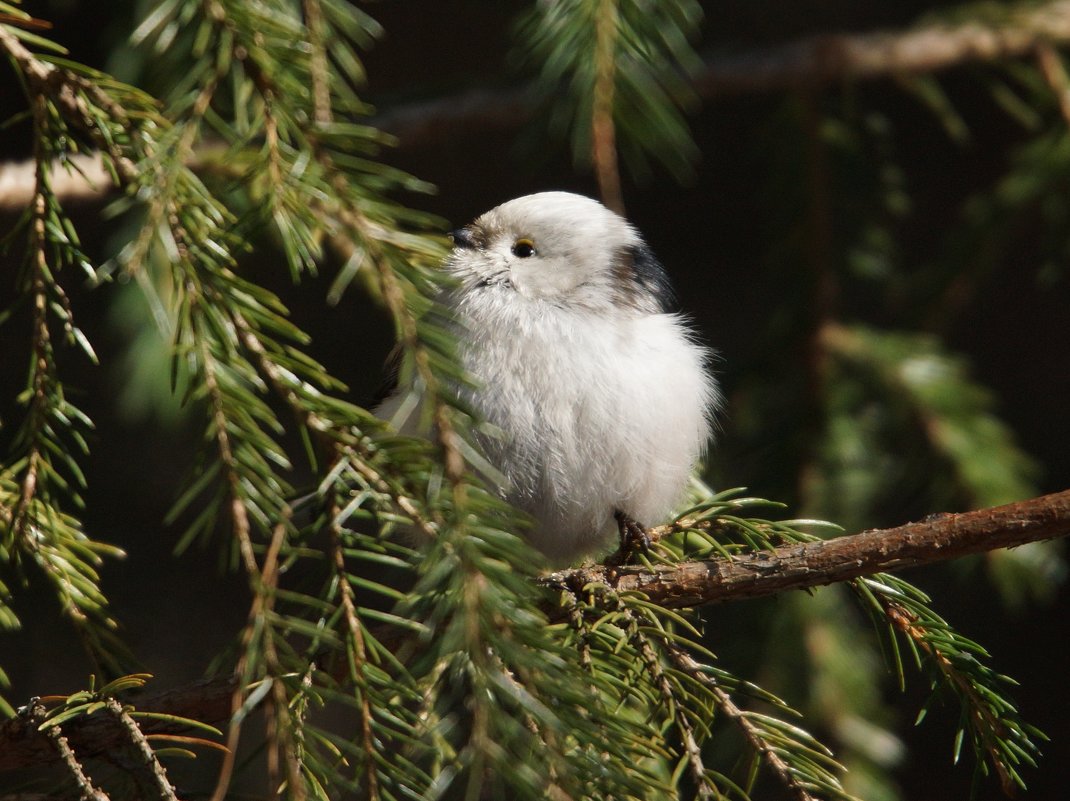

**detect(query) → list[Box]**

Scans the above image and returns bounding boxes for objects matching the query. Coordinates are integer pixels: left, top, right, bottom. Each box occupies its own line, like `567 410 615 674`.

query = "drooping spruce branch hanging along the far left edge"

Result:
0 18 127 669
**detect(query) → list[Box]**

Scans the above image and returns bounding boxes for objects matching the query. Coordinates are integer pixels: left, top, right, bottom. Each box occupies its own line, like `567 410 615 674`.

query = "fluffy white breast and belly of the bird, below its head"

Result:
458 289 716 561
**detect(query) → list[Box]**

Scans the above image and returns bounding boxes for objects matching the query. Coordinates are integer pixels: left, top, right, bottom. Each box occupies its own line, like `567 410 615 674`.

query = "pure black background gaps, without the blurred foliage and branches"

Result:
0 0 1070 801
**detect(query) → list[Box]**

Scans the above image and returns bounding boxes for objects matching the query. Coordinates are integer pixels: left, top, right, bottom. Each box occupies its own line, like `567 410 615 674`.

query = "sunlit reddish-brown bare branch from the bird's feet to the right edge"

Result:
546 490 1070 609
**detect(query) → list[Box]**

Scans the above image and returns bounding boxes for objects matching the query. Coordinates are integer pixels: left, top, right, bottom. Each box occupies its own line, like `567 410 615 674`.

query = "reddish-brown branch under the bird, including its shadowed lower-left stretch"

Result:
0 490 1070 771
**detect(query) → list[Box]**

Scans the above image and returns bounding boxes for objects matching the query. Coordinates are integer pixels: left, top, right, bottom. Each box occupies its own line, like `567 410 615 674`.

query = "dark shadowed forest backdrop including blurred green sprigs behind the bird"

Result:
0 0 1070 801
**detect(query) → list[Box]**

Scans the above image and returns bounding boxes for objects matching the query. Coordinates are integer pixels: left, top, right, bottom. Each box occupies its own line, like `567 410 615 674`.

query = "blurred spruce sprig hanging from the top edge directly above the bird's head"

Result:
518 0 702 193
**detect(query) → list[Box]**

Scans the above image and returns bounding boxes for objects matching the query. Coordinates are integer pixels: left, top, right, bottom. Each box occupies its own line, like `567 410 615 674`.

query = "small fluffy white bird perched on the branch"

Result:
379 191 719 564
